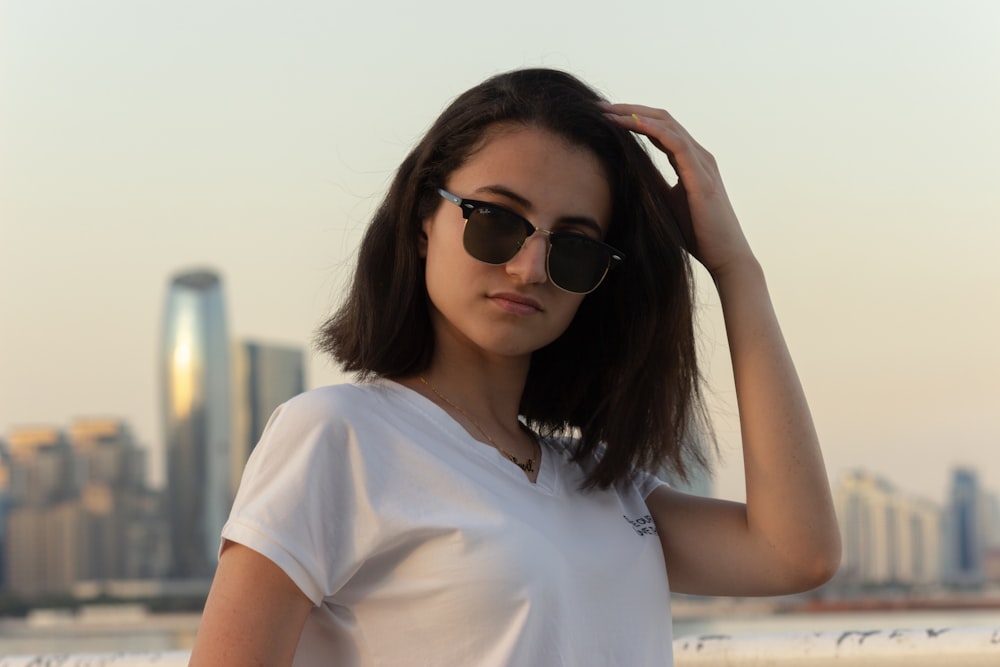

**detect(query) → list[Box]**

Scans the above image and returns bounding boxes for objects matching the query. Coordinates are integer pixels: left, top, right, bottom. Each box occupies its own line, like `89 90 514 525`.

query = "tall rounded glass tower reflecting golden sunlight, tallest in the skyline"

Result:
161 271 230 578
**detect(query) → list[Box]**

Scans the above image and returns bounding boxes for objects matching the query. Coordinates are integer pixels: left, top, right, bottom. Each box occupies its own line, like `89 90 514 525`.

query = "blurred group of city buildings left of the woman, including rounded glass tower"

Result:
0 282 304 588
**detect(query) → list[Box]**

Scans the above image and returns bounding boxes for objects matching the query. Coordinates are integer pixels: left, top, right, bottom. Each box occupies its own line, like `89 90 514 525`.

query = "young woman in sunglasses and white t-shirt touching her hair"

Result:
192 70 840 666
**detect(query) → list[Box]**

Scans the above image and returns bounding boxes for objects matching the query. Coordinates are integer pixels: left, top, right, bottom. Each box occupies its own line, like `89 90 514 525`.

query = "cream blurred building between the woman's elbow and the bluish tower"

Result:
834 471 942 586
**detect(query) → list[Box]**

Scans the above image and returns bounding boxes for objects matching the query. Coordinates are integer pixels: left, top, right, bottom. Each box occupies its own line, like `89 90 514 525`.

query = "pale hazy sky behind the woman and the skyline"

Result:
0 0 1000 500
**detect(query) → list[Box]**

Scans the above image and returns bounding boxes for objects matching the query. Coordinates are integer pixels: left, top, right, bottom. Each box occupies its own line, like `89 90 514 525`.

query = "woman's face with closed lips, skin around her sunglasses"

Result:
421 126 611 366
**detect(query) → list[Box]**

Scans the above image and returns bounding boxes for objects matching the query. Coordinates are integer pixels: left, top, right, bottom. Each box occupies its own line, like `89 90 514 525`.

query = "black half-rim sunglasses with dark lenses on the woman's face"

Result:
438 188 625 294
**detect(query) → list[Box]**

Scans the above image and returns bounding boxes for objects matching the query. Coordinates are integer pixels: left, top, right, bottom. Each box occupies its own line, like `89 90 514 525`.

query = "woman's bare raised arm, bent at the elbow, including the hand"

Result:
605 104 841 595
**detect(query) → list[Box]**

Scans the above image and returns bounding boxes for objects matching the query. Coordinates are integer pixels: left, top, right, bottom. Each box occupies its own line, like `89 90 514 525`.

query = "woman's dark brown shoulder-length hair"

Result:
317 69 707 488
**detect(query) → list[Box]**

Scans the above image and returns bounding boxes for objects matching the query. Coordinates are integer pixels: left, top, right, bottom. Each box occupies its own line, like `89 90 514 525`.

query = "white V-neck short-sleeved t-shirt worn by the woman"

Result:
222 380 673 667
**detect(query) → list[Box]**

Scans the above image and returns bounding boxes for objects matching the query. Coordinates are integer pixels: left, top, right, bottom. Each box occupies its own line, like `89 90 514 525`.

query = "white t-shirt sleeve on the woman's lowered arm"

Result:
222 394 375 605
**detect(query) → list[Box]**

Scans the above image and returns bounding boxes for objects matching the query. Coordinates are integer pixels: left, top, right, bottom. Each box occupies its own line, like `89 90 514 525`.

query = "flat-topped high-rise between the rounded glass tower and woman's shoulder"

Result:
230 341 305 497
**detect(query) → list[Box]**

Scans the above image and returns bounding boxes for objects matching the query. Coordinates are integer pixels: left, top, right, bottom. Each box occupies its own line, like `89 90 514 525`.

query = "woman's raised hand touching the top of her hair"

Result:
601 103 753 276
